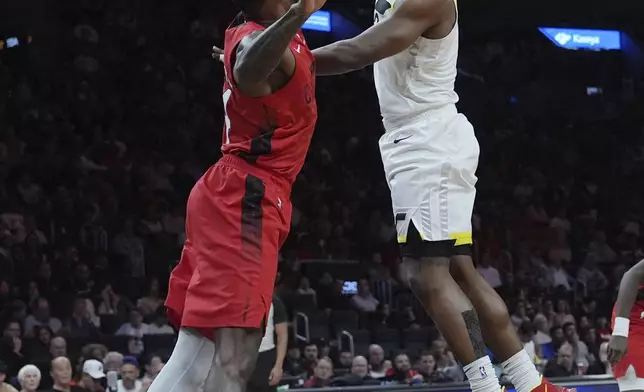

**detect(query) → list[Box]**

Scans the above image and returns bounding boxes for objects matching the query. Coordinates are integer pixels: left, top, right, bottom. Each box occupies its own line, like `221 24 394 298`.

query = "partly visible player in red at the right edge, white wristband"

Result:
608 260 644 391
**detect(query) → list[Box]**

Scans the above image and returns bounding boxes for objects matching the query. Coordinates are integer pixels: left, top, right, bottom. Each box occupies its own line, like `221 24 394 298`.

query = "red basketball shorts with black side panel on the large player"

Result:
165 155 291 337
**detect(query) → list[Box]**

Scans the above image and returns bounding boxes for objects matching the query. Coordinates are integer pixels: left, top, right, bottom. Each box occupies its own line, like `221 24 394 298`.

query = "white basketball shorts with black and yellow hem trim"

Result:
380 105 480 246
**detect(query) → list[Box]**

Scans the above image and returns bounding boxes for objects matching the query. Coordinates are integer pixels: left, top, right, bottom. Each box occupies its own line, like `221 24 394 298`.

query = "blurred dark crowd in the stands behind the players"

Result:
0 0 644 392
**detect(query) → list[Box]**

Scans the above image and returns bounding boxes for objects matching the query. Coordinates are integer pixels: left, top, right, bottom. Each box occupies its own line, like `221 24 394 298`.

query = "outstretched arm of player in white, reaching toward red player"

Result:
313 0 453 75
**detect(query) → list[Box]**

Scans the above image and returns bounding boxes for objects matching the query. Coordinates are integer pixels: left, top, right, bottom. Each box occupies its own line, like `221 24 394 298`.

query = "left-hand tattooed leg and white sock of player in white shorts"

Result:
400 224 501 392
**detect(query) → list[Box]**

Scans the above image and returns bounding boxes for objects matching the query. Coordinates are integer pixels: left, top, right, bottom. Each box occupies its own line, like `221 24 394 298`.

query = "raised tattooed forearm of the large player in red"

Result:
235 6 308 84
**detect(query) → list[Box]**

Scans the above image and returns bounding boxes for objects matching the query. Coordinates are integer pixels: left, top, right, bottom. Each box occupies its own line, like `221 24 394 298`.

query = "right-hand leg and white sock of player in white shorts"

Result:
450 252 551 392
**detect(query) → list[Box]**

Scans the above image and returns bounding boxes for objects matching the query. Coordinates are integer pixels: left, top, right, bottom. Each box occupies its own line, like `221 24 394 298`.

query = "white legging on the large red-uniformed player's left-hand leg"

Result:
148 328 215 392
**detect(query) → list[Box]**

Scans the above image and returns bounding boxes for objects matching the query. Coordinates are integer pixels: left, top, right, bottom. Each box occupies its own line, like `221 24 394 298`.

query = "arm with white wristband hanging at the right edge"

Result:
608 260 644 364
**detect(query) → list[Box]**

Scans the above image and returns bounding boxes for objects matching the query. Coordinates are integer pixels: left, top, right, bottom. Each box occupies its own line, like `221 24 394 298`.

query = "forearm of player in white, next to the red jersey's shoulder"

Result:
313 40 371 76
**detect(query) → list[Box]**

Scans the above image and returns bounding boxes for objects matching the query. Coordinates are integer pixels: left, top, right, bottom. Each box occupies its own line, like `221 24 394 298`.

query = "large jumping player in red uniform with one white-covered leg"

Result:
149 0 326 392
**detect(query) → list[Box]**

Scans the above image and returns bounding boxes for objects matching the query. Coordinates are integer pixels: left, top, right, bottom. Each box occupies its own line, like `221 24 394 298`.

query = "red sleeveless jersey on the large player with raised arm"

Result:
221 15 318 183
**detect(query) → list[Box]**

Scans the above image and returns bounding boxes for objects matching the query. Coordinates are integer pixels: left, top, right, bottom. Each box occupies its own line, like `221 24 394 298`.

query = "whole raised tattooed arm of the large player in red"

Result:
233 0 326 90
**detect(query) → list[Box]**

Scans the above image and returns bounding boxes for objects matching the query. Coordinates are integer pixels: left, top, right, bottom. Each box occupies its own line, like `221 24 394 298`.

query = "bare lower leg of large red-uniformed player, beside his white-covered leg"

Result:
209 328 264 392
